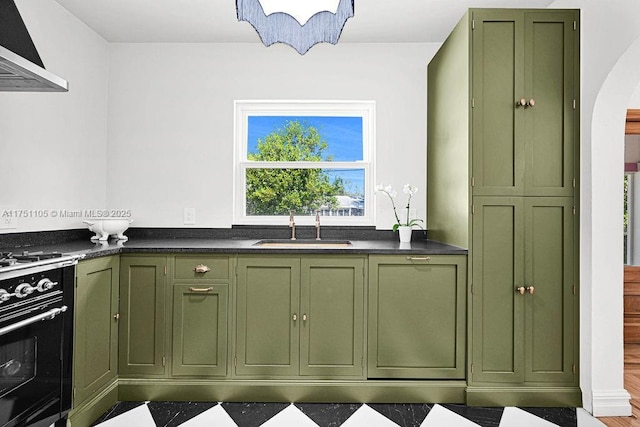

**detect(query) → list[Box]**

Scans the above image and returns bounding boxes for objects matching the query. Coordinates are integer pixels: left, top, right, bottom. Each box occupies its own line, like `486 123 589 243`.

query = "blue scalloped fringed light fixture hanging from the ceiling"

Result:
236 0 353 55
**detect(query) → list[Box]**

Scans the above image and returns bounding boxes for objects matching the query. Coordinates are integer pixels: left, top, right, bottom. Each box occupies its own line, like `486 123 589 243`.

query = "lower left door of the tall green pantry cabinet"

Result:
470 197 526 383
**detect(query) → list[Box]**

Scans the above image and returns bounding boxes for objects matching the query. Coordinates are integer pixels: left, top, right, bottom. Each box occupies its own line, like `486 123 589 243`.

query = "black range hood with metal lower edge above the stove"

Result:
0 0 69 92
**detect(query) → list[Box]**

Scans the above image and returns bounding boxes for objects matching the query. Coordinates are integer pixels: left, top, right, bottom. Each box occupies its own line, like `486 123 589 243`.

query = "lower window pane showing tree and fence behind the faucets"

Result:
246 168 365 216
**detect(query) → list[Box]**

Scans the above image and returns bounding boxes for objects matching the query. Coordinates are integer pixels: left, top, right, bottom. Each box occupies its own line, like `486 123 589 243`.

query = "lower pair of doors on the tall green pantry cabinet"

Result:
471 197 577 384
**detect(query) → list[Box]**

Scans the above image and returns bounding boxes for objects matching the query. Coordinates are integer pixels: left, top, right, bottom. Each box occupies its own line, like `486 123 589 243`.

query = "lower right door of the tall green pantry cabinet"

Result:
524 197 578 384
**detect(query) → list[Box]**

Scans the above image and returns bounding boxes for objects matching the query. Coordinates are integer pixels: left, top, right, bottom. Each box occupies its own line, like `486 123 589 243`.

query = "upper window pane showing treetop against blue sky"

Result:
247 116 363 162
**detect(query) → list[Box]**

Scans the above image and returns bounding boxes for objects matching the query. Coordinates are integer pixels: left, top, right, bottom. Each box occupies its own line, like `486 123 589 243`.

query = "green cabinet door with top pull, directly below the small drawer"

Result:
171 283 229 376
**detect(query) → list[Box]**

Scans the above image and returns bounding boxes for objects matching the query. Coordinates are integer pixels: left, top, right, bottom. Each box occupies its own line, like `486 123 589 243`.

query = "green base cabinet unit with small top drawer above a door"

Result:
171 255 232 377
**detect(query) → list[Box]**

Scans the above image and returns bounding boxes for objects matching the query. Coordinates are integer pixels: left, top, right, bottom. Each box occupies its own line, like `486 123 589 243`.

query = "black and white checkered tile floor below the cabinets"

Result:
94 402 604 427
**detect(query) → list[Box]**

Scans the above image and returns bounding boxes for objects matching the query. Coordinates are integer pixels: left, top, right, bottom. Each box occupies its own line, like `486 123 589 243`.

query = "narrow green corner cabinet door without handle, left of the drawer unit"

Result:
119 255 167 376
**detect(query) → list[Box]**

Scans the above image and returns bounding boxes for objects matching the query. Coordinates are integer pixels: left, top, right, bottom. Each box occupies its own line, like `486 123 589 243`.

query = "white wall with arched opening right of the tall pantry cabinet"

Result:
553 0 640 416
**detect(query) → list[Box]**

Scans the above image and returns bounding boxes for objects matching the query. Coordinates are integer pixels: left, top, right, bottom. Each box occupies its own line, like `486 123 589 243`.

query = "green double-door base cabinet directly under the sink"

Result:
235 255 365 378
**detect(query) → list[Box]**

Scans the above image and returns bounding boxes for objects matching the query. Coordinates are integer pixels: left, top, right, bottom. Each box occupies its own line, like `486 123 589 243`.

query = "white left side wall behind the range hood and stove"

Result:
0 0 108 233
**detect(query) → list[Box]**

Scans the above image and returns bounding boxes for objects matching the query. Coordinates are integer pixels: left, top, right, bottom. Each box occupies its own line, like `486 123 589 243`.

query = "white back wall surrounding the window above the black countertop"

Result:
107 43 439 228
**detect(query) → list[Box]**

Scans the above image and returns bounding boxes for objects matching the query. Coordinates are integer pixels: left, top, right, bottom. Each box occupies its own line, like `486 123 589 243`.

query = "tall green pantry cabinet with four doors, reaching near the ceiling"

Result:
427 9 581 406
